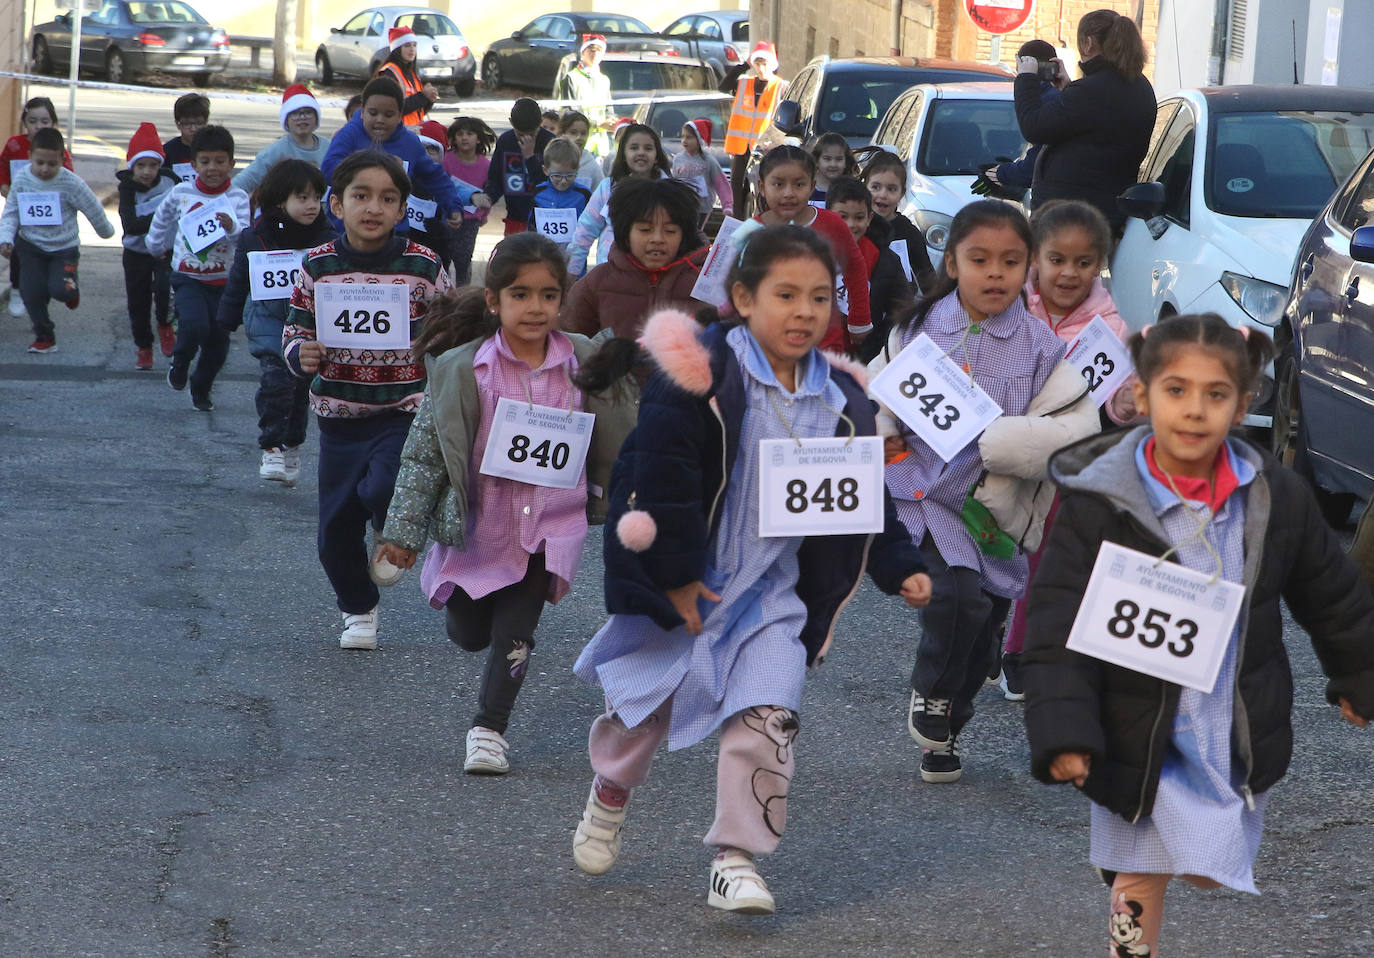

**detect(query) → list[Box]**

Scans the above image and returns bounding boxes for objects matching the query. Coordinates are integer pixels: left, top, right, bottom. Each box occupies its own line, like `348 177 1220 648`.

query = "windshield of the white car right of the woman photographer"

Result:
1205 110 1374 220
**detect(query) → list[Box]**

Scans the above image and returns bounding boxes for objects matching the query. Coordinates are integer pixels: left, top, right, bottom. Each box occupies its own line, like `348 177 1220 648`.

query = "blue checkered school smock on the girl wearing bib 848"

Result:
573 326 845 749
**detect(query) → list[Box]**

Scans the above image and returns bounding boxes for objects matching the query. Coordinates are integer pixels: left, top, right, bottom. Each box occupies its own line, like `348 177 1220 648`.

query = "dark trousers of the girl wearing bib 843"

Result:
911 533 1011 734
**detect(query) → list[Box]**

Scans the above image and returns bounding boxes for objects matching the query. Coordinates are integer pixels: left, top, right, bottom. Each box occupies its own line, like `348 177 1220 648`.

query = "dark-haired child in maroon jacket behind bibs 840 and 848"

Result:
559 177 706 339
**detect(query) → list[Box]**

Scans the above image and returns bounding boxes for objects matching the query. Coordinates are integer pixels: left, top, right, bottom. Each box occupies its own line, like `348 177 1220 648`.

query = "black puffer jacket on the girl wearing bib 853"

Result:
1022 426 1374 821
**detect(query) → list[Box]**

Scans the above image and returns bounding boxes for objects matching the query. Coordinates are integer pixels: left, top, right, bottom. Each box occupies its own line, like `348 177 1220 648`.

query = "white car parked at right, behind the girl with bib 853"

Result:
1112 87 1374 427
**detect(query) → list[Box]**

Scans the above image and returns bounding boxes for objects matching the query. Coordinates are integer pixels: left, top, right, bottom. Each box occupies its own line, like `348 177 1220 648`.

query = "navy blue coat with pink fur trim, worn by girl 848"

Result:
605 319 926 664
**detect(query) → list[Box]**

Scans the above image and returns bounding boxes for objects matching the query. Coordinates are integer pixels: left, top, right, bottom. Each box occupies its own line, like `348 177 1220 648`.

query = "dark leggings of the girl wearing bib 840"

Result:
444 553 550 735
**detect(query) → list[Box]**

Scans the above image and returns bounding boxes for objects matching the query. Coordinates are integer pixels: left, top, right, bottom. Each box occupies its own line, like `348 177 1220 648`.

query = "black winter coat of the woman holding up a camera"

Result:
1015 56 1156 230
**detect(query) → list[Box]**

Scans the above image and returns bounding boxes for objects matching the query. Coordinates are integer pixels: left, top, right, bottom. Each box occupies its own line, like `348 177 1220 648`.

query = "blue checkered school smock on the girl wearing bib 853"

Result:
1090 437 1268 895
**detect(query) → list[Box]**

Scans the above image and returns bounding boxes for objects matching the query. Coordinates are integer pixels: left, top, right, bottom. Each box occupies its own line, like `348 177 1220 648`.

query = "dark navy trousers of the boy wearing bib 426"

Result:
315 412 414 614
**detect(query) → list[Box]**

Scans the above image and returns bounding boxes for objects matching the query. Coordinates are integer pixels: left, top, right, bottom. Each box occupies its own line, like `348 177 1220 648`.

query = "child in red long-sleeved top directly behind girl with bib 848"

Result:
754 146 872 353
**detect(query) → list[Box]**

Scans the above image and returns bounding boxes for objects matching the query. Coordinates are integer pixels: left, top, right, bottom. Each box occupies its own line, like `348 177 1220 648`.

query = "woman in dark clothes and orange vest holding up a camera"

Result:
1015 10 1156 236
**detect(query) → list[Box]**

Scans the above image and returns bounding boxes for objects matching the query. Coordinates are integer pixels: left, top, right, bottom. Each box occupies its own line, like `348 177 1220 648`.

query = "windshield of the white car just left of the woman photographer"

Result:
916 99 1026 176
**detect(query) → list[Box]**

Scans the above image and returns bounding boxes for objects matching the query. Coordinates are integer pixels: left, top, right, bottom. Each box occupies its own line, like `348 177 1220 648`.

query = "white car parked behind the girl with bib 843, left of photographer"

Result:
872 82 1026 267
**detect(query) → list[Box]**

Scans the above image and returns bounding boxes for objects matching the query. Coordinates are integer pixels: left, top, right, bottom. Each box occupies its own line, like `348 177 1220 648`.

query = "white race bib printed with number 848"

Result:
758 436 883 537
